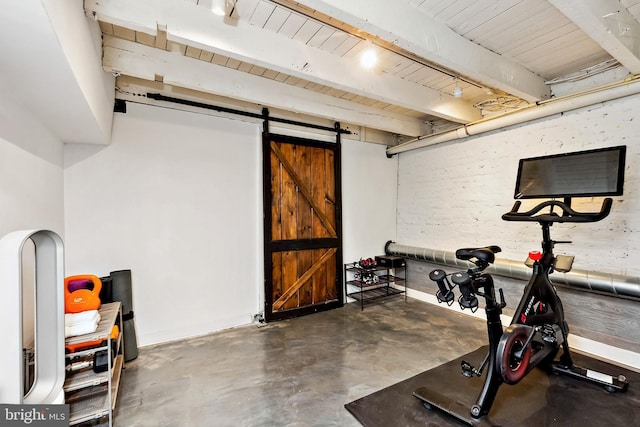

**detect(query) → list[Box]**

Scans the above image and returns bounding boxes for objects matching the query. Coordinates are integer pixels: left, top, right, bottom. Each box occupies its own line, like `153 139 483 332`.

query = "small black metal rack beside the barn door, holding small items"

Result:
344 262 407 310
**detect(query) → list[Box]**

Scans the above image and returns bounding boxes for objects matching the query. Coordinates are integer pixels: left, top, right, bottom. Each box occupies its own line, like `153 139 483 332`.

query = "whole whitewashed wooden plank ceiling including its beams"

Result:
85 0 640 137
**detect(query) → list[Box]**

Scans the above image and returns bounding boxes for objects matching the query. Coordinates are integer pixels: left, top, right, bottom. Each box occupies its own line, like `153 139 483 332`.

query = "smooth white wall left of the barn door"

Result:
65 103 262 345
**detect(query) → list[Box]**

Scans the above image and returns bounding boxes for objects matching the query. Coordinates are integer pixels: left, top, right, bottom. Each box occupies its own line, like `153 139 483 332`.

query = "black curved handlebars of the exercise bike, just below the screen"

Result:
502 197 612 223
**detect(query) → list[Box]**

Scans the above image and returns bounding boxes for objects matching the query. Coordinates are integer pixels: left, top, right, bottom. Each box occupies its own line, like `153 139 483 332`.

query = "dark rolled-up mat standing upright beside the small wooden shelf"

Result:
110 270 138 362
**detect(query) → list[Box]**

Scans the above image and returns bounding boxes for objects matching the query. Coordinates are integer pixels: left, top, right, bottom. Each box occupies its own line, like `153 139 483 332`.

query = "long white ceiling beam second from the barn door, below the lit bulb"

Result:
85 0 481 123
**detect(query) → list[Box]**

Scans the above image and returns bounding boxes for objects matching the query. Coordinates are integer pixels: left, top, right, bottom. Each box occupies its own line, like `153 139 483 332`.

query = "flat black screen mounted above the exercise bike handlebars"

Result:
514 145 627 199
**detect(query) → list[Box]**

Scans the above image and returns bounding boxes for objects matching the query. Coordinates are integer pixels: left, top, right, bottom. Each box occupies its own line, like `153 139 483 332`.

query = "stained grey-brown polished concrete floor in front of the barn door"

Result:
114 297 487 427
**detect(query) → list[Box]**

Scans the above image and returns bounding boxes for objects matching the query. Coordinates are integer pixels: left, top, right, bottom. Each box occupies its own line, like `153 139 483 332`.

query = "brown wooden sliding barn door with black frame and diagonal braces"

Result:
263 132 343 321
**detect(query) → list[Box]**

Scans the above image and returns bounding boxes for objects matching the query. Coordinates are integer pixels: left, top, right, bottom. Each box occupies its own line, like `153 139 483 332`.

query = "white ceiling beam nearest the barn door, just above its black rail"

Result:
103 36 430 136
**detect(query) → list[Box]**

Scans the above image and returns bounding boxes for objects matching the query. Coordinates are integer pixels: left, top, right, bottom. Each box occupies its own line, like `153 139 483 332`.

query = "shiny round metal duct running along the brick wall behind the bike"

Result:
385 242 640 300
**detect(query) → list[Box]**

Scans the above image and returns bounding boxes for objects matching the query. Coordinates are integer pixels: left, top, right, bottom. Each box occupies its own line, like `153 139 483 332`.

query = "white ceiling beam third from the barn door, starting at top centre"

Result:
297 0 550 102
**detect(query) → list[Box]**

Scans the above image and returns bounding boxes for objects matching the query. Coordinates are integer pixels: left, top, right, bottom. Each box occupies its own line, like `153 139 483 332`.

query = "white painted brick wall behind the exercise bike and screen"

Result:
396 96 640 276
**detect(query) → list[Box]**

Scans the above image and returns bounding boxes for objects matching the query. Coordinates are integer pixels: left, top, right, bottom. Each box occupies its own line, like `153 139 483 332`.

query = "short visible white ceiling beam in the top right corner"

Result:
549 0 640 74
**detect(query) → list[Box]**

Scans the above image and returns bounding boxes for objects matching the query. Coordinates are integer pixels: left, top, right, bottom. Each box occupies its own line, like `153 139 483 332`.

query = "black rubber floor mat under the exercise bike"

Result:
345 347 640 427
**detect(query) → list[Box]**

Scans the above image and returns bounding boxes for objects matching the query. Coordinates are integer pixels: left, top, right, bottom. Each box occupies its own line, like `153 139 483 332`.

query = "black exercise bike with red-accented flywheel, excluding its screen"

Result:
414 198 628 421
